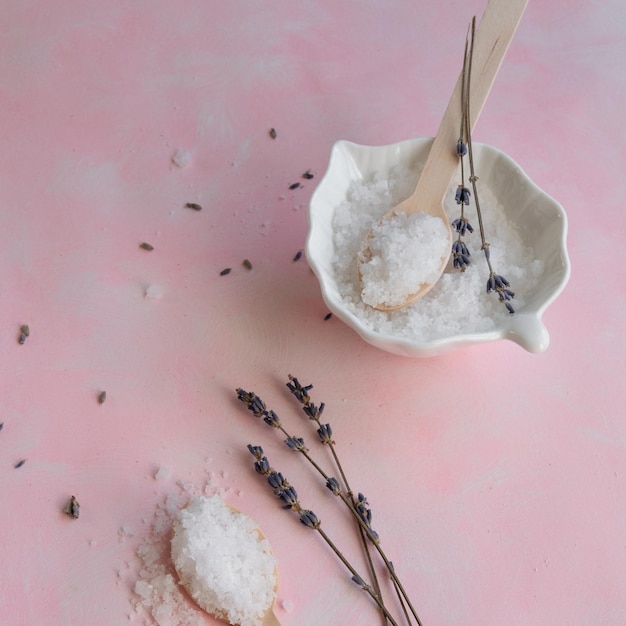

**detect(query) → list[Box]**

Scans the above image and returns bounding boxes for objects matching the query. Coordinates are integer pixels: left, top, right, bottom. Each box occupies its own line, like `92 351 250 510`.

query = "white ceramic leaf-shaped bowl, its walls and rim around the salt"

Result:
306 138 570 357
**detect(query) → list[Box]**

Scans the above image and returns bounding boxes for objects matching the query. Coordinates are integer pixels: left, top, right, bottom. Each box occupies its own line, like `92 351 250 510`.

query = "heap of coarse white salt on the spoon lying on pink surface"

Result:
172 495 277 626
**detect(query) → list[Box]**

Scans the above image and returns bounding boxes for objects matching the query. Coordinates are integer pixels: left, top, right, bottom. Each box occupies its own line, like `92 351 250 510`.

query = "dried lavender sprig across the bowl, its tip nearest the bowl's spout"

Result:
462 17 515 315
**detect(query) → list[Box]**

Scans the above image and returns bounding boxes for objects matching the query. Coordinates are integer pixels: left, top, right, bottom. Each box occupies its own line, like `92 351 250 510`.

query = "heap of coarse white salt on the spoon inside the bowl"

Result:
359 212 450 307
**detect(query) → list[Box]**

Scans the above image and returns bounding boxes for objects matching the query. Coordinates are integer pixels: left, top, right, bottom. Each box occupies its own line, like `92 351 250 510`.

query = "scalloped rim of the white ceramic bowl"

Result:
305 137 571 357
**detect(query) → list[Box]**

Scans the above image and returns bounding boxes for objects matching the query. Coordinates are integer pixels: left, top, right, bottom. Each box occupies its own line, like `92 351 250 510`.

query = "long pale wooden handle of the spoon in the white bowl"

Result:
413 0 528 208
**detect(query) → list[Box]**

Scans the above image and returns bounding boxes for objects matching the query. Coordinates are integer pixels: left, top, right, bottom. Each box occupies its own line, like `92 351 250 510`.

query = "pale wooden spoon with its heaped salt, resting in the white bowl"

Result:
357 0 528 311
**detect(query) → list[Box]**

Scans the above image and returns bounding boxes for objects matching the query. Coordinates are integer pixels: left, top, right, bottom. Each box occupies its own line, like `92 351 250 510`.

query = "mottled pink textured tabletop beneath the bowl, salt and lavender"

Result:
0 0 626 626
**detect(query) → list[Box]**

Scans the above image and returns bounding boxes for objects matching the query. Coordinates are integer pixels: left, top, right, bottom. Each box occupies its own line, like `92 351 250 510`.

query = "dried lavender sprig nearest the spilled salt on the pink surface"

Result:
248 444 398 626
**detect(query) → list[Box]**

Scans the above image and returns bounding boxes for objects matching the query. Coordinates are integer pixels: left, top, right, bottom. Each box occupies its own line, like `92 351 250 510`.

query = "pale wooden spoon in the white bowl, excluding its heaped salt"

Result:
358 0 528 311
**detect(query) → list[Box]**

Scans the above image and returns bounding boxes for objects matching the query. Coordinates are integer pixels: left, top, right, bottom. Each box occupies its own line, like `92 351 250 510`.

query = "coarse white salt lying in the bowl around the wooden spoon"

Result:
332 164 544 341
